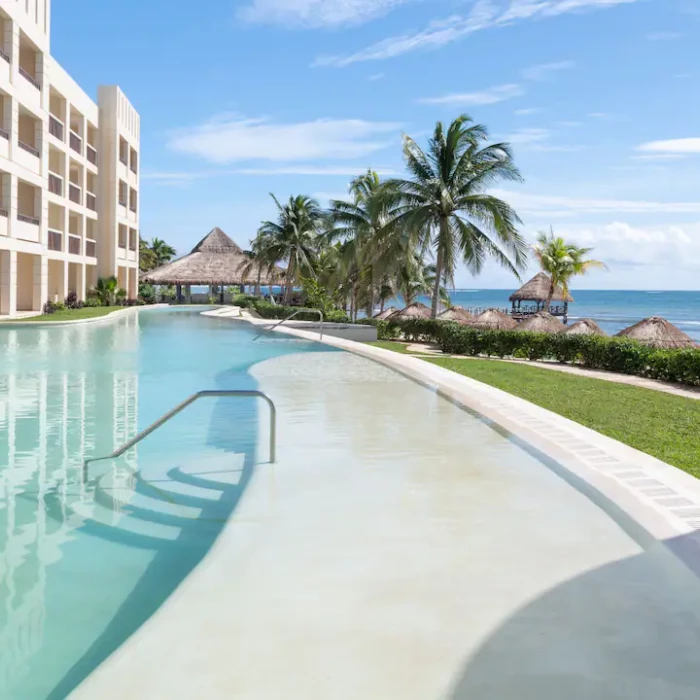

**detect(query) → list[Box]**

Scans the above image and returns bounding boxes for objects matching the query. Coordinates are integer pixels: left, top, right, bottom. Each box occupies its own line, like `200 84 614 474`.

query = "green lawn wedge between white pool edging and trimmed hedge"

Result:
427 358 700 477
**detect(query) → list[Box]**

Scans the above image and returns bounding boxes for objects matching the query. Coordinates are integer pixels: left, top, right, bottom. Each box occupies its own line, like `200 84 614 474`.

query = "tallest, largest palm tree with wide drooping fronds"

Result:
390 115 527 318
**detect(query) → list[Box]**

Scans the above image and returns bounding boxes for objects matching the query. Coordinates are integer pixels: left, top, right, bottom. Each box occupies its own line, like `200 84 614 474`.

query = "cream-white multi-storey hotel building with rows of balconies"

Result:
0 0 140 317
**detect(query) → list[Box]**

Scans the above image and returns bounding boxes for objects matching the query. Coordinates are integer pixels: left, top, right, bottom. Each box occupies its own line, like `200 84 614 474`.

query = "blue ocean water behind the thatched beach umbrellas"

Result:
416 289 700 341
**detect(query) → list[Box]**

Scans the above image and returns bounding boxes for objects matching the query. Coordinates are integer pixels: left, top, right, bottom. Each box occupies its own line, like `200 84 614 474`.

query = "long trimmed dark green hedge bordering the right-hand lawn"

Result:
361 318 700 386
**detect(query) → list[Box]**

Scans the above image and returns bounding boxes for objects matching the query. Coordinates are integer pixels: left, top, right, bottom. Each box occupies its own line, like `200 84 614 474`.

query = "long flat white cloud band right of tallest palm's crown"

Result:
493 189 700 216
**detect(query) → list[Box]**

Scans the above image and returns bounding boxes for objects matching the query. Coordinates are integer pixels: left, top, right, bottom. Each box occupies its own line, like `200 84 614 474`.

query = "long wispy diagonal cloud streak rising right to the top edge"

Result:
314 0 640 67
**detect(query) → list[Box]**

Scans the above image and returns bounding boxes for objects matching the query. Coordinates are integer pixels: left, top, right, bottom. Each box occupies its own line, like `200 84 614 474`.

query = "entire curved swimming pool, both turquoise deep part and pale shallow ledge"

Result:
0 310 700 700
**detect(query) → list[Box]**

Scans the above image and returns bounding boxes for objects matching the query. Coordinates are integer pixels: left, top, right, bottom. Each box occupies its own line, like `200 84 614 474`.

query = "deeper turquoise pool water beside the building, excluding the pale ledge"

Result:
0 310 328 700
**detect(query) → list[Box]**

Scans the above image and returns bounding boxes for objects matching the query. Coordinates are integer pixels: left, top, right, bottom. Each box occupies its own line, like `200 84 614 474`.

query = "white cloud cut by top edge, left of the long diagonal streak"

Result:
238 0 412 27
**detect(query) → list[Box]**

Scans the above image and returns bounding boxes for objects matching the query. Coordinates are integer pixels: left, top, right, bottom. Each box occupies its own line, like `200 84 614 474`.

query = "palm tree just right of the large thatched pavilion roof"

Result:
255 194 325 303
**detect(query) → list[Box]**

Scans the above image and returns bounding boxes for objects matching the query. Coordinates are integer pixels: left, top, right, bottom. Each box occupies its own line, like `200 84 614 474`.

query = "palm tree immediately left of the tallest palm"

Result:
329 170 398 312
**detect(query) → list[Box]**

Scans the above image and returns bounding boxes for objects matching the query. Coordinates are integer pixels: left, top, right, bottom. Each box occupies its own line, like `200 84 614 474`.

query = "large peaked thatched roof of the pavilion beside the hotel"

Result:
143 227 284 286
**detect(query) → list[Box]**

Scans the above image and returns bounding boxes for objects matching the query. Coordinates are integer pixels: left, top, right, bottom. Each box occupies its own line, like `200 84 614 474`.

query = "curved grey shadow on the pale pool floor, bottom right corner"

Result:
449 535 700 700
